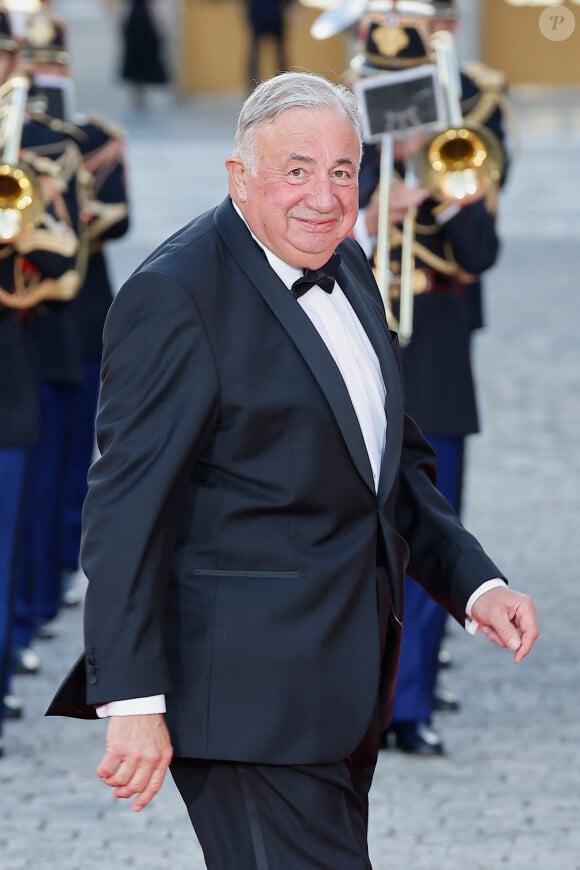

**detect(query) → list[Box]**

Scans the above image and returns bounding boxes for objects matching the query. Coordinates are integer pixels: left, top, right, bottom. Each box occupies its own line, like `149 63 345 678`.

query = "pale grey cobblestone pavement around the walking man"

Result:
0 0 580 870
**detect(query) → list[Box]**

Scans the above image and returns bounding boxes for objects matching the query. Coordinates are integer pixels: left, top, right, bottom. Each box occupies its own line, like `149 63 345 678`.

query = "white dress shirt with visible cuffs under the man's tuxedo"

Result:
97 215 504 718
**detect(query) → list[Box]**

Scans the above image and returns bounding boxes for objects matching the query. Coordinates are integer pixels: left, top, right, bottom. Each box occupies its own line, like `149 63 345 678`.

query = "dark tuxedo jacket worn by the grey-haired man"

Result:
49 199 499 763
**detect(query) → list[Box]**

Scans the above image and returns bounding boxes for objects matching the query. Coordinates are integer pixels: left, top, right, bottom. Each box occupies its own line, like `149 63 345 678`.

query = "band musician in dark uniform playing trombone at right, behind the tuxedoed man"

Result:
352 2 507 755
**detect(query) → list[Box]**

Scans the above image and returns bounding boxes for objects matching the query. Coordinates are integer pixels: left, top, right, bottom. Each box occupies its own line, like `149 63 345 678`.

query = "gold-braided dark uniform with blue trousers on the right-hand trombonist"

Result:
352 10 507 754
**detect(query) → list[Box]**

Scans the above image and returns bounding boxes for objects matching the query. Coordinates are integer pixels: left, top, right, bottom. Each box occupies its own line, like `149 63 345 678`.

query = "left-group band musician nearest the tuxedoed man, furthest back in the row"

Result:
11 12 129 604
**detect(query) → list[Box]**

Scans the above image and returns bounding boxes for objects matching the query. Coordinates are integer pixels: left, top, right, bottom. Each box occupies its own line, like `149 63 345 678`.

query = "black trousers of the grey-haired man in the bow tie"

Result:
171 568 390 870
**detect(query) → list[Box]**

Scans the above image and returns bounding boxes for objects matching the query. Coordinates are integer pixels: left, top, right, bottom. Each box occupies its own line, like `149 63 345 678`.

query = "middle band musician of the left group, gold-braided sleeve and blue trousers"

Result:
0 9 86 692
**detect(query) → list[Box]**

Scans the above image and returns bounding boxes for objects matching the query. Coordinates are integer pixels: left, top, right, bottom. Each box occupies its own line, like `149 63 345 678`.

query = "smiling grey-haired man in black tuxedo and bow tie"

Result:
49 73 537 870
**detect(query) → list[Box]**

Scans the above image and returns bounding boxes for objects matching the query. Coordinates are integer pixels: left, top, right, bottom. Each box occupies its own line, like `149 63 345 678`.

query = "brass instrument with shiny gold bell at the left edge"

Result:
0 75 44 243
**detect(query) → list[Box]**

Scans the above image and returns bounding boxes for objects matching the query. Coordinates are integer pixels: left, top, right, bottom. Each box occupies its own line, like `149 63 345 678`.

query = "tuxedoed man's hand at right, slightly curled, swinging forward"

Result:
471 586 540 664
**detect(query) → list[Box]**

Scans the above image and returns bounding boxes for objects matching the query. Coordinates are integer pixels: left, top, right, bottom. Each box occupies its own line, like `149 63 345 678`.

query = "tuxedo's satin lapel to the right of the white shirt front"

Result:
338 259 403 497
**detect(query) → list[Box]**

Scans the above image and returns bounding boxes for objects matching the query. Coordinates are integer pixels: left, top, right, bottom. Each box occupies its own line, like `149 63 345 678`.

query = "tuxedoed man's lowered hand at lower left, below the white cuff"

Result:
97 713 173 813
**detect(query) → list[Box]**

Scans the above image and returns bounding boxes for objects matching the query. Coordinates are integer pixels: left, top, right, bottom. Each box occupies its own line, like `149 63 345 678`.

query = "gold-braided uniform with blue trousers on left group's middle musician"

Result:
9 119 86 649
